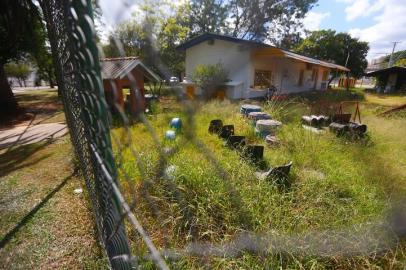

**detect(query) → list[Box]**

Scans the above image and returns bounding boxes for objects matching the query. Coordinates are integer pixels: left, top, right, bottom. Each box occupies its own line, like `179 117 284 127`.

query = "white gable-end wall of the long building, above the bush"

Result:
185 40 251 88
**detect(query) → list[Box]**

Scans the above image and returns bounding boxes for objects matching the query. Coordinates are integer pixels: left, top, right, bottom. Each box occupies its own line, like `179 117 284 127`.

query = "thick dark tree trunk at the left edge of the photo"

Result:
0 63 18 117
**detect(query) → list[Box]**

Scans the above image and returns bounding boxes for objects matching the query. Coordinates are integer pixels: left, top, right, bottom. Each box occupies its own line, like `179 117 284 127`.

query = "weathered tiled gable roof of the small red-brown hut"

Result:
100 56 161 81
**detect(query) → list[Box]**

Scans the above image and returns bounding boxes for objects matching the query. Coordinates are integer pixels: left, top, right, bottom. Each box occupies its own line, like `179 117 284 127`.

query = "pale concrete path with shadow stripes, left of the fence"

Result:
0 123 68 149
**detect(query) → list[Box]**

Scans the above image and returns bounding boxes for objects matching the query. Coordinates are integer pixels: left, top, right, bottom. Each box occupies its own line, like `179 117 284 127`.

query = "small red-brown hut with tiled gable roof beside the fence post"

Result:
100 57 160 113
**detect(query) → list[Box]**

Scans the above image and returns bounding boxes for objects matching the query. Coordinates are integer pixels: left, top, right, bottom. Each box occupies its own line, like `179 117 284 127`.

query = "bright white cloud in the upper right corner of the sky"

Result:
349 0 406 59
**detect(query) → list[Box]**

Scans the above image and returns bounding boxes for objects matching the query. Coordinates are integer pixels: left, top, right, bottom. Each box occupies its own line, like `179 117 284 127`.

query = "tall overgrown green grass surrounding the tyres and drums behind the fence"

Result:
113 91 406 269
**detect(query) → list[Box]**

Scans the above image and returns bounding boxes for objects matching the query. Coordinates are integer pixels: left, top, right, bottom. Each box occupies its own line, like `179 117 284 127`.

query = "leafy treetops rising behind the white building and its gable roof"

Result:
103 0 317 77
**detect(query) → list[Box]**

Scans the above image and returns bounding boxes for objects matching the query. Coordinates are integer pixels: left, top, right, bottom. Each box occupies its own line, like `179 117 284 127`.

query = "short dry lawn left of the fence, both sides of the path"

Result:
0 90 108 269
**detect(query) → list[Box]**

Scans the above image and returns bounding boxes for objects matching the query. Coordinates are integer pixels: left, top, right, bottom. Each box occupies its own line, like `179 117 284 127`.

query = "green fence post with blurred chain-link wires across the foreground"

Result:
40 0 404 269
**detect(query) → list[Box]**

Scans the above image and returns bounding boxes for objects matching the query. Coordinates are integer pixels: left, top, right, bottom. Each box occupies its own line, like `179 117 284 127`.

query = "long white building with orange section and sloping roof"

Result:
178 34 349 99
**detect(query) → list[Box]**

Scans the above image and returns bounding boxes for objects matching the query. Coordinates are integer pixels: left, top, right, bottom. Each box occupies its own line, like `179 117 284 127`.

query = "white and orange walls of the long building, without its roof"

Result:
185 40 329 99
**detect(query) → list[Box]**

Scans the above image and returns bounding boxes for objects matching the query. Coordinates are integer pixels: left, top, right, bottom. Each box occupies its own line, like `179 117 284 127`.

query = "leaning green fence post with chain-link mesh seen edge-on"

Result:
40 0 131 269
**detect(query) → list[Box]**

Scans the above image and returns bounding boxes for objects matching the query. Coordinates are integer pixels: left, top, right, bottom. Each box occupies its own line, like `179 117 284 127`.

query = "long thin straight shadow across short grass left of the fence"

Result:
0 170 76 249
